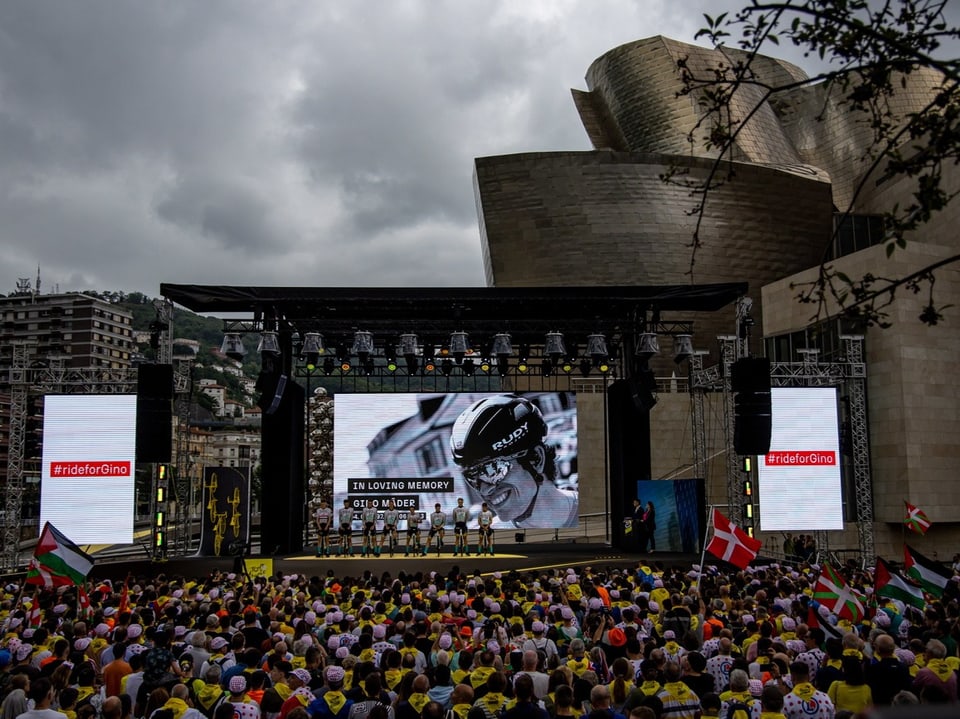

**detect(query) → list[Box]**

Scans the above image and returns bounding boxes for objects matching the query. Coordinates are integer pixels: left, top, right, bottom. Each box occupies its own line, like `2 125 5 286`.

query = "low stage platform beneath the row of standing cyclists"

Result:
91 543 699 581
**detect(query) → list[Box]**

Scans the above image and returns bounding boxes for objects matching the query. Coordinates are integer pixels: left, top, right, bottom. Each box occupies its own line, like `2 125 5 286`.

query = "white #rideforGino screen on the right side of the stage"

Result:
757 387 843 532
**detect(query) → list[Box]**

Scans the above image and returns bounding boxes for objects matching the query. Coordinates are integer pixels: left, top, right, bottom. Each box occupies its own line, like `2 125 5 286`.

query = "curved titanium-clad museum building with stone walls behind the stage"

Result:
474 37 960 561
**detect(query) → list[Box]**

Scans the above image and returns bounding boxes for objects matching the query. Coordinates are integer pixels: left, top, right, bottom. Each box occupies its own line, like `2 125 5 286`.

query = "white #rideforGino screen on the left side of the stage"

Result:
40 394 137 544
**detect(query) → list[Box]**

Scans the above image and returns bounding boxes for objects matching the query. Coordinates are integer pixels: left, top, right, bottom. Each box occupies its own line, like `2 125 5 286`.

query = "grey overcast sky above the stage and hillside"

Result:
0 0 908 296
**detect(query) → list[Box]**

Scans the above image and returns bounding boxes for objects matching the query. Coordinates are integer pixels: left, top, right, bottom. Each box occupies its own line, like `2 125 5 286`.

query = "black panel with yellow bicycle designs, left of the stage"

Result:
197 467 250 557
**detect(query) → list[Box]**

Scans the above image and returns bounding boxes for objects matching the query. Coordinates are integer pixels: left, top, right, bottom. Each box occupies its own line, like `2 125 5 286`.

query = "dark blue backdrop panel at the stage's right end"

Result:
627 479 706 554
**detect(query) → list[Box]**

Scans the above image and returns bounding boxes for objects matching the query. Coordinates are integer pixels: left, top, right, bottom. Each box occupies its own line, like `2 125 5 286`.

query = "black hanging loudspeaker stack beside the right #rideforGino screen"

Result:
730 357 773 454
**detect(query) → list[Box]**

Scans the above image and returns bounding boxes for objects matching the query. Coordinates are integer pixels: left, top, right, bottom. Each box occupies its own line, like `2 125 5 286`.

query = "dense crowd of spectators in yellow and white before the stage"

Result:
0 563 960 719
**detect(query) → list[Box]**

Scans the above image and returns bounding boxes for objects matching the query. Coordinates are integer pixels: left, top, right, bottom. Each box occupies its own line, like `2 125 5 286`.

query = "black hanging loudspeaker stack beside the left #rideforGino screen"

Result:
136 364 173 463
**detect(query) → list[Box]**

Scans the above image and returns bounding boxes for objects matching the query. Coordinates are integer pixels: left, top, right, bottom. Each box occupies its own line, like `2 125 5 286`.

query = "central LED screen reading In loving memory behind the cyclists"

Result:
333 392 579 531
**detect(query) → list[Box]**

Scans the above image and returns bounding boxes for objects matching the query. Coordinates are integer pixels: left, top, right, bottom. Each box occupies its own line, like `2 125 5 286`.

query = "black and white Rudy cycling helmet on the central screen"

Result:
450 395 547 467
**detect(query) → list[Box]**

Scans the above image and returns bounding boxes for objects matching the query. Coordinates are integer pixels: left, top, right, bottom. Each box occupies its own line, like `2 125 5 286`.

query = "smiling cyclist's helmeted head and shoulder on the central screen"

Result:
450 395 579 527
